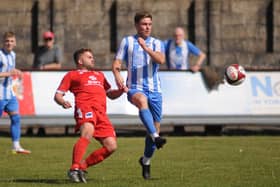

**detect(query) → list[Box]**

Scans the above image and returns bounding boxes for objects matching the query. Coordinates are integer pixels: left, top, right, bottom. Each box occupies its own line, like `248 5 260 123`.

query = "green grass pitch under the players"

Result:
0 136 280 187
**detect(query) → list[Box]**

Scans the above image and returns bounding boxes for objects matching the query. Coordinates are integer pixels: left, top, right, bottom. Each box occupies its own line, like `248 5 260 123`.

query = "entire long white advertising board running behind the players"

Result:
31 71 280 116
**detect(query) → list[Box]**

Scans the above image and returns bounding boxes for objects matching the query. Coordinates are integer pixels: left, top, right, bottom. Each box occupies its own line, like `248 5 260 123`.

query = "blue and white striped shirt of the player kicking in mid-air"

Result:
115 35 164 92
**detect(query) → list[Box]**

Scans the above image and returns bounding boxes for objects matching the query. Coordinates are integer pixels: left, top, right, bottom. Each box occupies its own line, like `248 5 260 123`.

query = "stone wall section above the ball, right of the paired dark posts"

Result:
209 0 280 68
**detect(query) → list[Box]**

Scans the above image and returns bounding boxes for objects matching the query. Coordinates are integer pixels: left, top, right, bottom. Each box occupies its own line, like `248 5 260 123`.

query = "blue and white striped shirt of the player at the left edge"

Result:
0 49 16 100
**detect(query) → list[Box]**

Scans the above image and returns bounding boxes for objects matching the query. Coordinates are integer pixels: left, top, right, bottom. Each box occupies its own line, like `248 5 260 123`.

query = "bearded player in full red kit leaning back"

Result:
54 48 125 183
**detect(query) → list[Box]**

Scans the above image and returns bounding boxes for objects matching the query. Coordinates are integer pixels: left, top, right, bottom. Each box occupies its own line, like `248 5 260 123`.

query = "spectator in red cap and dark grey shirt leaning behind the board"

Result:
33 31 62 70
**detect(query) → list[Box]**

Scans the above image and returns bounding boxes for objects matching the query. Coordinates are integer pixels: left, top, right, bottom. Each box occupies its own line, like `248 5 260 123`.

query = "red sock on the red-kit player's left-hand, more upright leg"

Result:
71 137 90 169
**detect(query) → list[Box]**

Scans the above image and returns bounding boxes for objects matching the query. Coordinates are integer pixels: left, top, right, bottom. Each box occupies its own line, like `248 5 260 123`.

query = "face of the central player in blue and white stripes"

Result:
135 18 152 39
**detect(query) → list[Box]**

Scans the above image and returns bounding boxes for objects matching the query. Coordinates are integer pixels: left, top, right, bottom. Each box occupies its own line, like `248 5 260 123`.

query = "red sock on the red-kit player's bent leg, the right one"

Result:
86 147 111 166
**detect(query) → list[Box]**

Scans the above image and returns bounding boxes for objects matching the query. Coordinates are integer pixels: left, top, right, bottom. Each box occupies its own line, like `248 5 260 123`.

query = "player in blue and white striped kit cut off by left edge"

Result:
0 32 31 154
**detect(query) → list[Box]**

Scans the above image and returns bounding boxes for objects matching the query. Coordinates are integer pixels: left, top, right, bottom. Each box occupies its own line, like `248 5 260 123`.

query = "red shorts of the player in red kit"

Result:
74 106 116 138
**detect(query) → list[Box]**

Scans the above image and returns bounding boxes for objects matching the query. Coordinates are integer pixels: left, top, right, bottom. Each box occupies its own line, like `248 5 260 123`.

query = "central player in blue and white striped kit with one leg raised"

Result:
112 12 166 179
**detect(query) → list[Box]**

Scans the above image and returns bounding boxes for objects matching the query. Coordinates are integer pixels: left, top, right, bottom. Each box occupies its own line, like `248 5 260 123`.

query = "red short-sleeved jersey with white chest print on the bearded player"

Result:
57 70 111 112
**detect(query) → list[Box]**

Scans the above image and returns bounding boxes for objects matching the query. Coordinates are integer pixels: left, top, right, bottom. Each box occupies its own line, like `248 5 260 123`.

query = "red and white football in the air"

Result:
225 64 246 86
